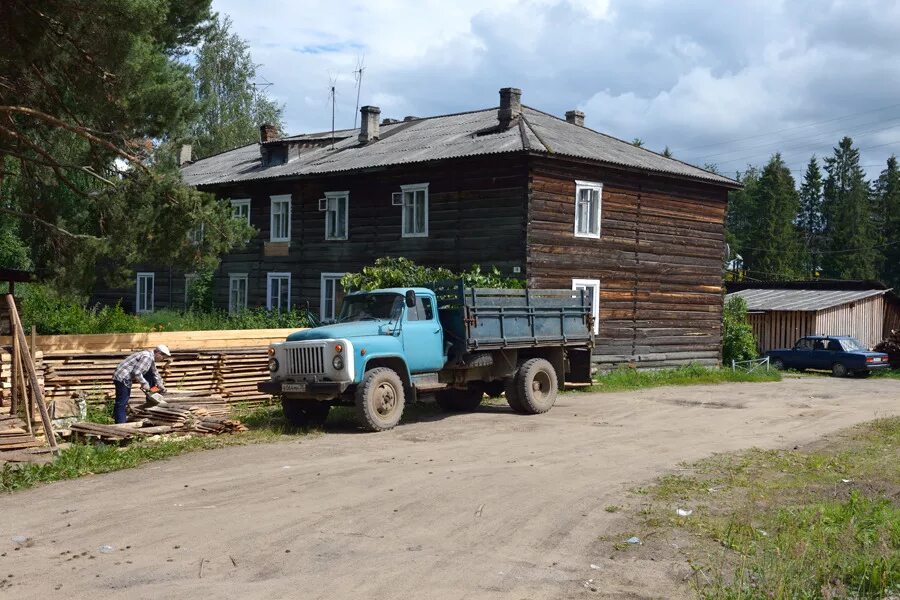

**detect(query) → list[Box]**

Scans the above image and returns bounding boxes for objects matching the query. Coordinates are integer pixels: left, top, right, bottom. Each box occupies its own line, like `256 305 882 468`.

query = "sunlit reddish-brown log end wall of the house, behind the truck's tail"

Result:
527 158 727 367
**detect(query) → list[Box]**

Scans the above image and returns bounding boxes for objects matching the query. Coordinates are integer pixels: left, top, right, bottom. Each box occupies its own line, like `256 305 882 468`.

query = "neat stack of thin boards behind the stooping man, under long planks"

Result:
0 348 271 410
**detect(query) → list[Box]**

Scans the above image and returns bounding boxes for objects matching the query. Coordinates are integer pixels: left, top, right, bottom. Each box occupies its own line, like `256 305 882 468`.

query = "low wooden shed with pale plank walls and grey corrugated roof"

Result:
727 281 900 352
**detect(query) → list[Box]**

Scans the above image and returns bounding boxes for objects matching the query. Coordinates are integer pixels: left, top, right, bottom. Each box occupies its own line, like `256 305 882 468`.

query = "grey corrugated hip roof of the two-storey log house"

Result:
182 107 739 187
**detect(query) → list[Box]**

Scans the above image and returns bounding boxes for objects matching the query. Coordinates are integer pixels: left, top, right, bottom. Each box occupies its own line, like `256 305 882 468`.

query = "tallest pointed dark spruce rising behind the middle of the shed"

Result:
822 137 878 279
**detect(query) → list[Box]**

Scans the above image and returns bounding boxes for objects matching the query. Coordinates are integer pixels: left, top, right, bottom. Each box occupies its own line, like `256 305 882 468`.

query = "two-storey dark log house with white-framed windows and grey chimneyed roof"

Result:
97 88 739 366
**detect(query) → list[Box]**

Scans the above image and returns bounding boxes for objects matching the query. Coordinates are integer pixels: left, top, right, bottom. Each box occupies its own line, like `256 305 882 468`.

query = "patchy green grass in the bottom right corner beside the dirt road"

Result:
635 418 900 600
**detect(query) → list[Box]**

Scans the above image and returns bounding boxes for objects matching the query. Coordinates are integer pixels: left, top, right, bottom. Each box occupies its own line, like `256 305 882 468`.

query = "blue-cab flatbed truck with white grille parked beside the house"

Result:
258 283 594 431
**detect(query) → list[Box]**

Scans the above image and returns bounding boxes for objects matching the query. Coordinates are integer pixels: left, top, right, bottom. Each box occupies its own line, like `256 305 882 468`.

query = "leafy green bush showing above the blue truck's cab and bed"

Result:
341 257 525 290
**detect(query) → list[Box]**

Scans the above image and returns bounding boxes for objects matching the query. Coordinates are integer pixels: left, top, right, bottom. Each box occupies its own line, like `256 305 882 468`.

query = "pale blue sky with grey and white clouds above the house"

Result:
213 0 900 177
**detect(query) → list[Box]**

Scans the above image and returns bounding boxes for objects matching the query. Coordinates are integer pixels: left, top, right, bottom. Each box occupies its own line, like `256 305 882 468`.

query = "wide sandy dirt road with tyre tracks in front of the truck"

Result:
0 377 900 600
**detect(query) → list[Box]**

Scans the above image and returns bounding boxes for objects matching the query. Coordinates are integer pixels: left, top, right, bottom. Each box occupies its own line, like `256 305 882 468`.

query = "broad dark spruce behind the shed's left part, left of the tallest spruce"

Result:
743 154 800 280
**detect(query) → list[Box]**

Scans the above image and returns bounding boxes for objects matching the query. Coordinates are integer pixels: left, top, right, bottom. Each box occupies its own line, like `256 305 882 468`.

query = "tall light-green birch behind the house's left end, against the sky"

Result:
191 17 282 158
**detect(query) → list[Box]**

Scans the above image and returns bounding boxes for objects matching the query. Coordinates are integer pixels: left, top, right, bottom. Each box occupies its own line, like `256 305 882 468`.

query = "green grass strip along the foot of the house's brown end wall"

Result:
582 365 781 392
